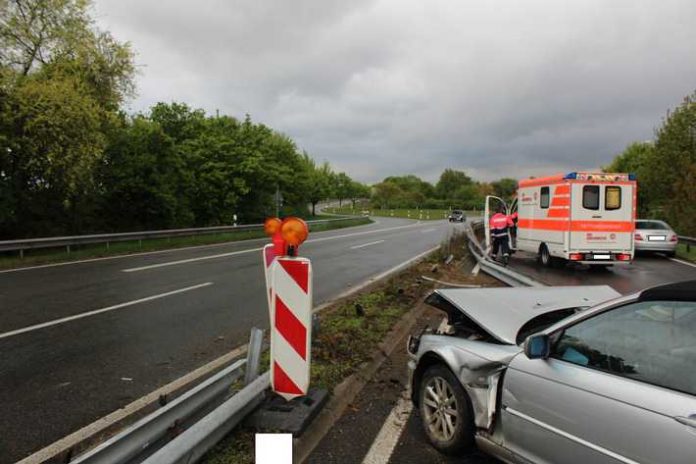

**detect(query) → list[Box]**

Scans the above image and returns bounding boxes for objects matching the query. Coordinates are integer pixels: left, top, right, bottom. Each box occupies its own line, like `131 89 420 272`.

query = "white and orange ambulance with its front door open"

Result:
485 172 638 266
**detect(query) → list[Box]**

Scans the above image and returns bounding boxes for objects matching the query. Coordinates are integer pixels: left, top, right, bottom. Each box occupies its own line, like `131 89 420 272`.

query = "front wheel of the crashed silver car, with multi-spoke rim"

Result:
418 364 475 454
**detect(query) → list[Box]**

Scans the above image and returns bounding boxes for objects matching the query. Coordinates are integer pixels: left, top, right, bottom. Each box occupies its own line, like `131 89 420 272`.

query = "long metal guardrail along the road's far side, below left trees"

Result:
0 217 361 253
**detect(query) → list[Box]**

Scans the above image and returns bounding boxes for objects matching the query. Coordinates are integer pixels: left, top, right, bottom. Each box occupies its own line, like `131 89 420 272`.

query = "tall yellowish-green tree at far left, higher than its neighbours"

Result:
0 0 133 237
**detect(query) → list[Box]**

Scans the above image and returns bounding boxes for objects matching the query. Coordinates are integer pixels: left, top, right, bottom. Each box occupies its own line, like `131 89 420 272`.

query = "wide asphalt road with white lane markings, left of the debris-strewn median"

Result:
0 218 459 463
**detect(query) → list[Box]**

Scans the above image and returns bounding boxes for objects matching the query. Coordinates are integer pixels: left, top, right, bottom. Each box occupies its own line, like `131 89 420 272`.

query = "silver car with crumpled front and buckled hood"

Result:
408 281 696 464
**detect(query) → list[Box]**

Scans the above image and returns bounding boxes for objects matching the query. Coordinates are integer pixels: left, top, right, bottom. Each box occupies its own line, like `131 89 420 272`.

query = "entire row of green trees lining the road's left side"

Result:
0 0 368 239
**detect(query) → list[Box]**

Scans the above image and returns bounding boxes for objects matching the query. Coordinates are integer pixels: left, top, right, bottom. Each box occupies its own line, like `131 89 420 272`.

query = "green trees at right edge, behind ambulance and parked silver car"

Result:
604 93 696 236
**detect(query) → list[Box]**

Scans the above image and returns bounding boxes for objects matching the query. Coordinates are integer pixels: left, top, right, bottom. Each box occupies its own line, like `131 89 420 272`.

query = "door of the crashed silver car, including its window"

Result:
502 301 696 464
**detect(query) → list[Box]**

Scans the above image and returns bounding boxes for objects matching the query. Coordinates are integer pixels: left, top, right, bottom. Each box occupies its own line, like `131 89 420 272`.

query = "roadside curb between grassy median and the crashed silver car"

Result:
293 302 426 464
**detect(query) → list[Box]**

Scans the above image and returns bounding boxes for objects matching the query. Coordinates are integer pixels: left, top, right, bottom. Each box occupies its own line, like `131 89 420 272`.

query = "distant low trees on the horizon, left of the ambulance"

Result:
370 169 517 210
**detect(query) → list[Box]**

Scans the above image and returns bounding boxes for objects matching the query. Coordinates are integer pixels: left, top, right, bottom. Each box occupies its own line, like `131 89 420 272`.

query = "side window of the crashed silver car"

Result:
551 301 696 395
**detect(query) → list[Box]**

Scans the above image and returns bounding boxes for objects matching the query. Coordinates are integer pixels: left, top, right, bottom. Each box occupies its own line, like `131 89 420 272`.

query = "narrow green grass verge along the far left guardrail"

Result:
0 216 372 269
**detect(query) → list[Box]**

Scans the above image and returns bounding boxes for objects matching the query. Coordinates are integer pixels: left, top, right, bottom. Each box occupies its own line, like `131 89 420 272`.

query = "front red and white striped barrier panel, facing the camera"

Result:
270 257 312 400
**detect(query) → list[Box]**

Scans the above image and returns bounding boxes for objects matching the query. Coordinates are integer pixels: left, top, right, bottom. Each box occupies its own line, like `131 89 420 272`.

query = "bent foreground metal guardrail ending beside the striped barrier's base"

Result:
71 328 270 464
